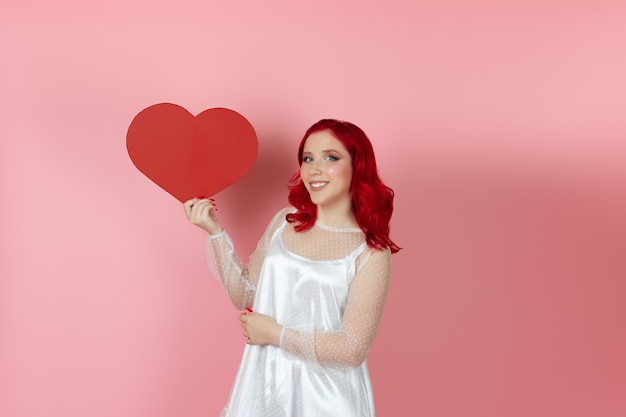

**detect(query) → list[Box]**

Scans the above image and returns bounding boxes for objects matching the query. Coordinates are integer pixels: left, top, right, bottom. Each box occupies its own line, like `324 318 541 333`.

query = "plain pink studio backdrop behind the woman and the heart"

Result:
0 0 626 417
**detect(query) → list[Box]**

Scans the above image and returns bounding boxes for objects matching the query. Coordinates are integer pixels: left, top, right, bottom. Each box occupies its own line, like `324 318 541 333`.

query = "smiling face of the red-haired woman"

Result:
300 130 352 208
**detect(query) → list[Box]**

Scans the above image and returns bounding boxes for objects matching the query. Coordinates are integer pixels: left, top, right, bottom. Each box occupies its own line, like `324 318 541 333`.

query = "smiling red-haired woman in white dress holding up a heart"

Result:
184 119 400 417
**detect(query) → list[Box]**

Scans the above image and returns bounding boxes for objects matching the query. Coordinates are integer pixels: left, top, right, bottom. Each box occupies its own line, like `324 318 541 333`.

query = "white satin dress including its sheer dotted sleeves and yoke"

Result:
208 211 389 417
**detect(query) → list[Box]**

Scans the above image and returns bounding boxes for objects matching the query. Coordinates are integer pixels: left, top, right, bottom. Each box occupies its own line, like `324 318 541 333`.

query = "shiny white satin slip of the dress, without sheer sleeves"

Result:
222 222 375 417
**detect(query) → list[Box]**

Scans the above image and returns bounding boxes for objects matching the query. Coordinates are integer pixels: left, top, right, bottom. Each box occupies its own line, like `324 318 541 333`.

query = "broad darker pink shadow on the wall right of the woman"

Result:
370 141 626 417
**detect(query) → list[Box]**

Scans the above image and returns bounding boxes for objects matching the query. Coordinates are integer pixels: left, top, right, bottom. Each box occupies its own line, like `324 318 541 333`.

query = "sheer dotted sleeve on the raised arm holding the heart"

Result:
206 208 289 310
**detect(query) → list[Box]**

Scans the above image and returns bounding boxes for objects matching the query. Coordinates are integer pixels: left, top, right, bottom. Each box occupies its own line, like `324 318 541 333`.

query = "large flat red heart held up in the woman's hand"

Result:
126 103 258 202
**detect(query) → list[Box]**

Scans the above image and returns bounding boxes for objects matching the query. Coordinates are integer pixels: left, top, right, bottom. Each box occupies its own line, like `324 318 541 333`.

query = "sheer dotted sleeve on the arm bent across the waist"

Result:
279 249 391 367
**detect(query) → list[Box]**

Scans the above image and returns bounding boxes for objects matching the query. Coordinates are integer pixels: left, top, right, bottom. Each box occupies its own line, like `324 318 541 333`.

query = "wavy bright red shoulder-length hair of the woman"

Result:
287 119 400 253
